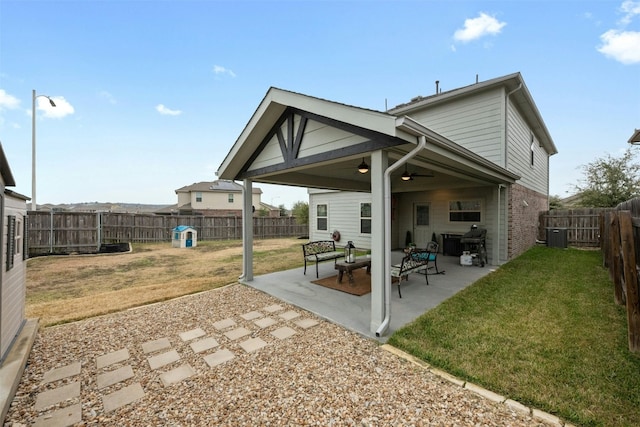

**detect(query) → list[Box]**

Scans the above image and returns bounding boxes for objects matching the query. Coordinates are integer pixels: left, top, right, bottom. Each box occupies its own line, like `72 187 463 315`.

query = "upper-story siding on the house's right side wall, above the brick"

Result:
506 100 549 194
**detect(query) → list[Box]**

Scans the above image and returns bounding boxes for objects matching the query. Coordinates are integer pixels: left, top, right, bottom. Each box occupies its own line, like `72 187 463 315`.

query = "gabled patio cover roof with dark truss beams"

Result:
216 80 520 191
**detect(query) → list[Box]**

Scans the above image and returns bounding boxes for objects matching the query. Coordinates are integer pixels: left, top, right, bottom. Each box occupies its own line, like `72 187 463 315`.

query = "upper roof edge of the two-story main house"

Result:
388 73 558 155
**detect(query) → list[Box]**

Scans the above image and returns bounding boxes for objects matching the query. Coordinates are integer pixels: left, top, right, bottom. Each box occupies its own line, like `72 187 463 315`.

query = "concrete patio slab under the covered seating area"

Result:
245 251 496 342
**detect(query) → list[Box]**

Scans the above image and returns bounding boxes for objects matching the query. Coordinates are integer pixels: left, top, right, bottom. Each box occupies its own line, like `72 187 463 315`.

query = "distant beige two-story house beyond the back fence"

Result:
174 180 280 217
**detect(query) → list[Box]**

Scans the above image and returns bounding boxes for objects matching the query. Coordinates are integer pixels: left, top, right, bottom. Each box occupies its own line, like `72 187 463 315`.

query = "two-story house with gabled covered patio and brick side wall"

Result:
218 73 557 335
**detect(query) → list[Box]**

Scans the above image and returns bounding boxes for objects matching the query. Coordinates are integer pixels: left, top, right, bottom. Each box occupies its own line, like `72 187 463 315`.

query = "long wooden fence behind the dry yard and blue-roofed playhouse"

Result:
27 211 309 256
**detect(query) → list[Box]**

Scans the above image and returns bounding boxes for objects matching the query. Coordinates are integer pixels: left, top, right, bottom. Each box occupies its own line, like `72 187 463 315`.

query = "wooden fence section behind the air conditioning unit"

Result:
538 208 610 247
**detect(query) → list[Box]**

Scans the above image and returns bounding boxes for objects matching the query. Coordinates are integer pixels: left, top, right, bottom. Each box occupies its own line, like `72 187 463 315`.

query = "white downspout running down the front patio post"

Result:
376 135 427 337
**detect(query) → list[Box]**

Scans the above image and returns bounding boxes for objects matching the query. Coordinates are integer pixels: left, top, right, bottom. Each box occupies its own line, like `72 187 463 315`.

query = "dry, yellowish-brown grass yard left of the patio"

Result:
26 238 302 327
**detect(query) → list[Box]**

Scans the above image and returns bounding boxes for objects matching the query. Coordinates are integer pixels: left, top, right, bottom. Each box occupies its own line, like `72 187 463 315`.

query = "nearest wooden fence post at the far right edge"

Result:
619 211 640 353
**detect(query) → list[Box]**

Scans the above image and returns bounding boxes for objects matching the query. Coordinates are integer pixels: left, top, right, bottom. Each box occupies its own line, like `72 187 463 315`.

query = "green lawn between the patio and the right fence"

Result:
389 247 640 426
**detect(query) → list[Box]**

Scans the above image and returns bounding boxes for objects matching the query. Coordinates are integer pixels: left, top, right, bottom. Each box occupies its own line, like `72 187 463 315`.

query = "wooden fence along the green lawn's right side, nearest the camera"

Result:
601 198 640 353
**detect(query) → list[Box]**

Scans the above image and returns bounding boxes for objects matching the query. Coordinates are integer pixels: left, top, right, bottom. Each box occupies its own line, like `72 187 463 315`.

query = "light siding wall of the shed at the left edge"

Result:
0 196 26 359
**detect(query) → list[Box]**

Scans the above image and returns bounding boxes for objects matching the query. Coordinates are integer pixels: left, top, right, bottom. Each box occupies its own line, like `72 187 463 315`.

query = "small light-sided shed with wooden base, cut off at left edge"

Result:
0 145 37 421
